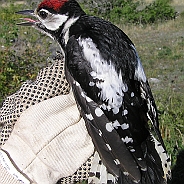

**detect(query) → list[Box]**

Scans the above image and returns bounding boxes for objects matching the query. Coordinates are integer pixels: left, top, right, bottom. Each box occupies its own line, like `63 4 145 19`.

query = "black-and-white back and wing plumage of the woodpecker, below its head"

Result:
65 4 170 184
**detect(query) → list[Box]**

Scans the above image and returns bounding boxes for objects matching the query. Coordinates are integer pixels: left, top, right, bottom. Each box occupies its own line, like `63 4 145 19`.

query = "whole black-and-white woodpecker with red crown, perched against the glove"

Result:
17 0 171 184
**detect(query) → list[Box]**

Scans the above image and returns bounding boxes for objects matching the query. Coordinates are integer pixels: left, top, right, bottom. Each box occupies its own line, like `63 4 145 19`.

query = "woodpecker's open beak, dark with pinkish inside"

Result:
16 10 40 26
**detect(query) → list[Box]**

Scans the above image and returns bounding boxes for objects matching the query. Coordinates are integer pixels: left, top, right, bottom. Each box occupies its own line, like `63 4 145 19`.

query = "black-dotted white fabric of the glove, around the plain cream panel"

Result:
0 54 93 184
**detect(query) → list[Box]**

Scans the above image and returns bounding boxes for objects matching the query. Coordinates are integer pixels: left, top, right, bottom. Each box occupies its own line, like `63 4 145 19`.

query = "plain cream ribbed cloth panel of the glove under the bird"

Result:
1 92 94 184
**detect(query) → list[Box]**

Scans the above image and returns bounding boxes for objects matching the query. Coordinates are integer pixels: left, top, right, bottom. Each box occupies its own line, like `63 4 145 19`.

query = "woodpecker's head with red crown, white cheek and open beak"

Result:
16 0 85 38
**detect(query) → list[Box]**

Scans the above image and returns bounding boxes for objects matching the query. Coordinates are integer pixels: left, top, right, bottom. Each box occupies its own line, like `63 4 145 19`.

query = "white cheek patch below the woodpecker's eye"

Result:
38 14 68 31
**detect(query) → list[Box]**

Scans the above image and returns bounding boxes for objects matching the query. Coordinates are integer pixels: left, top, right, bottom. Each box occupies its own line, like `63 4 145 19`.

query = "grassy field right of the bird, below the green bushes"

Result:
119 16 184 164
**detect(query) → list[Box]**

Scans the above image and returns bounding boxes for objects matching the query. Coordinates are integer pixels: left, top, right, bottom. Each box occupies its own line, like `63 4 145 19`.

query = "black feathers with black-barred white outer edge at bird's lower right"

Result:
141 136 171 184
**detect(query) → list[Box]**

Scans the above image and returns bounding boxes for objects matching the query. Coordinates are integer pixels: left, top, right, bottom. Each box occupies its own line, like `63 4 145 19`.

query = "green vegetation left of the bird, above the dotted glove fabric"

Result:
0 1 51 103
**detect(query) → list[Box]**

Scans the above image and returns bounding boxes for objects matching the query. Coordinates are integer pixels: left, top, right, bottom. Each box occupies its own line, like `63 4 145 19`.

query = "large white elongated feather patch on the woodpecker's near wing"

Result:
78 37 128 114
